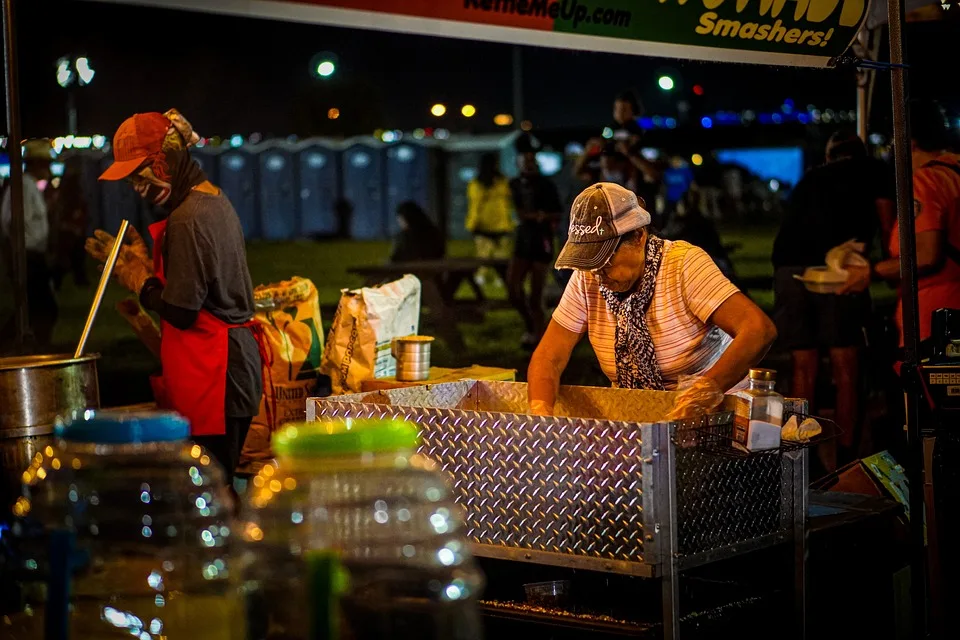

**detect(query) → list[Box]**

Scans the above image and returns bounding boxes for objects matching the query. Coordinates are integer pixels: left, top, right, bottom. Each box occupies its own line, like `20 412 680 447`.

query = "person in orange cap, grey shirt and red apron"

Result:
86 110 262 477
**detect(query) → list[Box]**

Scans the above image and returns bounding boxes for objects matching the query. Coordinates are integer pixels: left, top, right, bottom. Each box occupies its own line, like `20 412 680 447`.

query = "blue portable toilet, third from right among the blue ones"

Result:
296 138 340 236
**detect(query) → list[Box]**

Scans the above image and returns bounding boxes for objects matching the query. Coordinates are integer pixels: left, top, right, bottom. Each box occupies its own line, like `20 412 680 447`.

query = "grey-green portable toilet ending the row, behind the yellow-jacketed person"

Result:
444 132 520 239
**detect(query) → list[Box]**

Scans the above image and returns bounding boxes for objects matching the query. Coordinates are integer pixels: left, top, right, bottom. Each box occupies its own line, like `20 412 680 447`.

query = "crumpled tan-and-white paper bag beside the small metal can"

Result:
320 274 420 394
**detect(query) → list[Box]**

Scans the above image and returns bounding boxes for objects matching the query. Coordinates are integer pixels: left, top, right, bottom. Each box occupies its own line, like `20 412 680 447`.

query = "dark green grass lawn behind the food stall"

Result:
0 230 893 406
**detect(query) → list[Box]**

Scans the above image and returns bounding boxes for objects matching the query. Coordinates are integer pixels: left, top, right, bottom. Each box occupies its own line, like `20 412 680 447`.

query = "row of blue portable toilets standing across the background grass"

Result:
76 134 570 240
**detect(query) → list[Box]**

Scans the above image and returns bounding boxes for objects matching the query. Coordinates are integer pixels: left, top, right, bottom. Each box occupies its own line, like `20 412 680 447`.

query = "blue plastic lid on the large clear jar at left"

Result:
56 410 190 444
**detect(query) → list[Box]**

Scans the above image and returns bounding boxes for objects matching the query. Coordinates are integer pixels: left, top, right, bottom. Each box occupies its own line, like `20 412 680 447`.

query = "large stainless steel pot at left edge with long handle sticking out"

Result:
0 354 100 438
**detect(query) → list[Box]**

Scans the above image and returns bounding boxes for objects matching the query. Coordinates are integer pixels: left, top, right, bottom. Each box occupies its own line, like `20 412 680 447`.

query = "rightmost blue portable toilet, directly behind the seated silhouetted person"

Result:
387 140 437 237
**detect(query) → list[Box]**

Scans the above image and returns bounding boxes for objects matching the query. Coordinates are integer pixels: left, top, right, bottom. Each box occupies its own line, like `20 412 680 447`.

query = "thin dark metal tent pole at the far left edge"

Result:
2 0 30 347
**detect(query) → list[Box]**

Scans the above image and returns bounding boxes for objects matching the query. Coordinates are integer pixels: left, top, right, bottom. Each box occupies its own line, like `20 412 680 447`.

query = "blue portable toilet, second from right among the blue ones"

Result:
342 137 387 240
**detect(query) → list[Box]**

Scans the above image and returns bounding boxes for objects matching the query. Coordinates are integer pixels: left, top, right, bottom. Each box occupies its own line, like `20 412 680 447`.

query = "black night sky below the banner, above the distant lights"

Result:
7 0 960 137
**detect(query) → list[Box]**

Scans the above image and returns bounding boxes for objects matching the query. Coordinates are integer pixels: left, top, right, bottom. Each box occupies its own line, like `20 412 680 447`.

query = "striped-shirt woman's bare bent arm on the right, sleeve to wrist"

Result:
703 293 777 390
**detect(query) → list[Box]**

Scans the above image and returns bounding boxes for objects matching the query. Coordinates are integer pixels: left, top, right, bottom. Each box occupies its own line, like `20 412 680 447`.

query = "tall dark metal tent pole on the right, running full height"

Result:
887 0 927 640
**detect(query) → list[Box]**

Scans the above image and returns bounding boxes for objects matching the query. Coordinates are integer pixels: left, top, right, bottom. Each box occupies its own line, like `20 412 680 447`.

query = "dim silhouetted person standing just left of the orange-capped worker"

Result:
50 156 90 289
